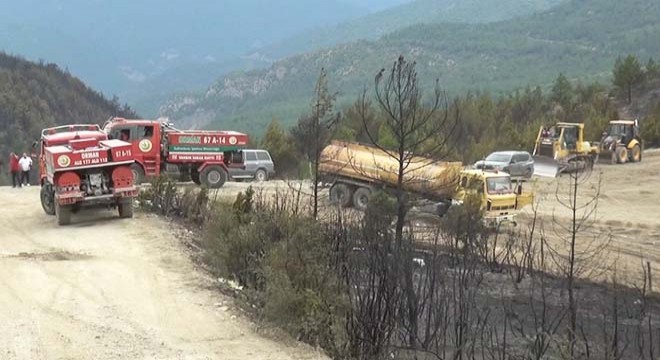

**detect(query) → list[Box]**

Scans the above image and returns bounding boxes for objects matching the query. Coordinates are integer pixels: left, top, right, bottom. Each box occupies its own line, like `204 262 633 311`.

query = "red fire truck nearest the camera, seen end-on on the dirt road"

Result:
35 125 137 225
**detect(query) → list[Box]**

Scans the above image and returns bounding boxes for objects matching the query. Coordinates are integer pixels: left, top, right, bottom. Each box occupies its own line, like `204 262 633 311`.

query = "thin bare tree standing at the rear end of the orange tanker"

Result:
291 68 339 218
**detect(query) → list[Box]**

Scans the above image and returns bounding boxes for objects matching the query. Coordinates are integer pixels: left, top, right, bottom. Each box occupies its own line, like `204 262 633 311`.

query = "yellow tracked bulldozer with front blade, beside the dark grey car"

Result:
532 122 599 177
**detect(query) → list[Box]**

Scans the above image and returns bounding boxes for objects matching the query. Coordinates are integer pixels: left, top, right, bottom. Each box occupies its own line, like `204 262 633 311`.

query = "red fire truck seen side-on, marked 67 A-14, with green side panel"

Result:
103 118 248 188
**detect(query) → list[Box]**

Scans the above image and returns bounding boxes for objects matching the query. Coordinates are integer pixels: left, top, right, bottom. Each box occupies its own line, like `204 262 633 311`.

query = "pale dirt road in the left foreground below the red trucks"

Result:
0 187 322 360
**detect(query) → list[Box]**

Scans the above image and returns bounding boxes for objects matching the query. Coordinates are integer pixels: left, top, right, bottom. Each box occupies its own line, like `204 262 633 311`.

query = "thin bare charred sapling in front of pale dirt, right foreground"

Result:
546 169 610 359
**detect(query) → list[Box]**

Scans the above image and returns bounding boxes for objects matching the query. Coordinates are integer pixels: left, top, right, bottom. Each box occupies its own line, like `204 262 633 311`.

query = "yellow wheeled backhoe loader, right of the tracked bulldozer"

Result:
598 120 644 164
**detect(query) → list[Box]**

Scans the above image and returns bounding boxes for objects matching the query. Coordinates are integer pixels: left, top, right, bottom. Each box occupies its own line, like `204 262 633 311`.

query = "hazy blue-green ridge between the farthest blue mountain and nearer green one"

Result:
260 0 564 57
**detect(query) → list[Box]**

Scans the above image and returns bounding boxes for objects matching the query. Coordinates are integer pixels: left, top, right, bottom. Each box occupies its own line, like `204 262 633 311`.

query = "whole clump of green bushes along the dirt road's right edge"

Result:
203 189 344 353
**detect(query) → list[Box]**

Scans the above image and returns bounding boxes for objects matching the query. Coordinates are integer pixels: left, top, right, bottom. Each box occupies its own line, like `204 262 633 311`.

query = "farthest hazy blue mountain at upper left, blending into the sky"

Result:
0 0 372 94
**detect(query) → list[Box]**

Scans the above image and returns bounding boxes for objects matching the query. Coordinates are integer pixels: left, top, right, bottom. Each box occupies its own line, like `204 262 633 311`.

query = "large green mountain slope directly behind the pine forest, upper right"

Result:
162 0 660 133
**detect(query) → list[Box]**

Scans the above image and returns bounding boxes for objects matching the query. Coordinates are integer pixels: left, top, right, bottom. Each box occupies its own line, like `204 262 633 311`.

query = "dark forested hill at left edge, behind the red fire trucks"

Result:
0 52 135 182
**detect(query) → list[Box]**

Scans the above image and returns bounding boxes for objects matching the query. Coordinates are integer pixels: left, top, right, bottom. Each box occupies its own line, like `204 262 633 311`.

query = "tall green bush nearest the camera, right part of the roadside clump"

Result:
264 218 345 352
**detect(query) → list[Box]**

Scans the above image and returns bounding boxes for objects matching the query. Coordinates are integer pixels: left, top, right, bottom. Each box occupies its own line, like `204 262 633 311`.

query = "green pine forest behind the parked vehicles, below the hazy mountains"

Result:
260 55 660 179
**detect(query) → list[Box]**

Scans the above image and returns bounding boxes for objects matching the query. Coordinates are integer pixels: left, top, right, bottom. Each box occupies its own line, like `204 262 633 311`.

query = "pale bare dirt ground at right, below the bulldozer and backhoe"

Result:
534 150 660 278
